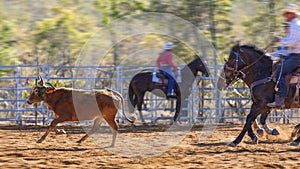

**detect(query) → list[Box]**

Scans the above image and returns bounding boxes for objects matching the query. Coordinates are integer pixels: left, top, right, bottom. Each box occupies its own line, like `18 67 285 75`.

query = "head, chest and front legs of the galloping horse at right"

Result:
218 44 300 146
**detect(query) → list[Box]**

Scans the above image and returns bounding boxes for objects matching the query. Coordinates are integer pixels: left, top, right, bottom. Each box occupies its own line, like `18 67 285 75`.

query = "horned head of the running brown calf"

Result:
27 77 55 104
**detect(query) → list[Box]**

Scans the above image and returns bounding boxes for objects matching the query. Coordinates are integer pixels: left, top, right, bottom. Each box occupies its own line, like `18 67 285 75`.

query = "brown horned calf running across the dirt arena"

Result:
27 78 134 147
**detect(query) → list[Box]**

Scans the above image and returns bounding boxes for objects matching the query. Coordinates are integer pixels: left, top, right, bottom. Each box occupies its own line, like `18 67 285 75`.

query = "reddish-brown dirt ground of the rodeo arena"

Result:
0 124 300 169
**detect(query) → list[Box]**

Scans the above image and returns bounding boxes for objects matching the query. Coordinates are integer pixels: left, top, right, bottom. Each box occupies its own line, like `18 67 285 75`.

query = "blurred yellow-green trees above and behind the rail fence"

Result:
0 0 300 69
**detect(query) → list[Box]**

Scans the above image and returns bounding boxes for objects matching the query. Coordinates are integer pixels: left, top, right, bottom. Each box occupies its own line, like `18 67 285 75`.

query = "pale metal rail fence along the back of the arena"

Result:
0 65 300 125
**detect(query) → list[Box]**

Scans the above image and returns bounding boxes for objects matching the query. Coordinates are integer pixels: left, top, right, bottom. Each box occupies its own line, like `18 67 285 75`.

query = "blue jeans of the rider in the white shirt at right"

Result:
276 53 300 98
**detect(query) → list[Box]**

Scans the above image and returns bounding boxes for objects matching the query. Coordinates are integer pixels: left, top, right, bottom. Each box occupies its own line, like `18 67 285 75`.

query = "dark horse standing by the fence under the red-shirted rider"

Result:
128 56 209 123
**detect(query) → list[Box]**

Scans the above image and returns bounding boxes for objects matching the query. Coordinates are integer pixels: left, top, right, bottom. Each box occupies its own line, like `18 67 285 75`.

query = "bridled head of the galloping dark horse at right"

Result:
218 43 250 90
